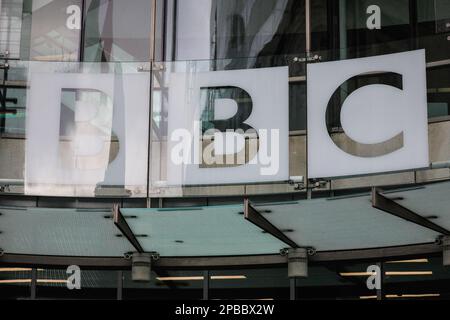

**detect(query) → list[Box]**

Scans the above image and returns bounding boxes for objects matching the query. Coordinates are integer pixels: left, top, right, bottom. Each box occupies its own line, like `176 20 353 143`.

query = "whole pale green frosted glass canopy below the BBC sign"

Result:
0 182 450 257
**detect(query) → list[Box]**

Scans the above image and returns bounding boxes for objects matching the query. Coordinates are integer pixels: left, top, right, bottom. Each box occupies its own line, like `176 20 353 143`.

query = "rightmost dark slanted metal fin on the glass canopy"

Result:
372 188 450 235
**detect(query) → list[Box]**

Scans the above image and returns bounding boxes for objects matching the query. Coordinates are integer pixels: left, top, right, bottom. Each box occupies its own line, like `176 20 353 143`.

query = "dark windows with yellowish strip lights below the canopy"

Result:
0 256 450 301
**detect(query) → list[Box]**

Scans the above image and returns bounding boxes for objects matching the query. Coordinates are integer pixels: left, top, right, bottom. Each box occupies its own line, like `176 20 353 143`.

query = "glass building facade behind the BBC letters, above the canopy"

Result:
0 0 450 197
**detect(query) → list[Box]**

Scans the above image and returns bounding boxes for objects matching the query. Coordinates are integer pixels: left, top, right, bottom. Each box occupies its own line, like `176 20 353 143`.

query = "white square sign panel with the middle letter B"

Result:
167 67 289 186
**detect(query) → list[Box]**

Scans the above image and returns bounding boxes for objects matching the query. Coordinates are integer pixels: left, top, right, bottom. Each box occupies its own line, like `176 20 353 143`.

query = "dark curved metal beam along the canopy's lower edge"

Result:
0 243 442 270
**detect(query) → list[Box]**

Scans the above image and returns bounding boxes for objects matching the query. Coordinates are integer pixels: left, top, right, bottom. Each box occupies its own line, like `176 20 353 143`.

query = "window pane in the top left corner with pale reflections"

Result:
0 0 81 61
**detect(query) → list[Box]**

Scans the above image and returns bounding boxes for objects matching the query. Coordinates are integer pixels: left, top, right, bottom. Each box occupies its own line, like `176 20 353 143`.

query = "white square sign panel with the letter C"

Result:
307 50 429 178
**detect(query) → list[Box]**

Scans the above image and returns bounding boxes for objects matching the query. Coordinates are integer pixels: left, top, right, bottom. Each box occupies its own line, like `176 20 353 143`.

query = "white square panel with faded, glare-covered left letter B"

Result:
25 65 150 196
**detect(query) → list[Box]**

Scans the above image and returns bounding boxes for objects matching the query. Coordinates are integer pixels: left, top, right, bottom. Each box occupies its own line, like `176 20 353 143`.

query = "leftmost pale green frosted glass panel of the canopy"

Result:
0 207 133 257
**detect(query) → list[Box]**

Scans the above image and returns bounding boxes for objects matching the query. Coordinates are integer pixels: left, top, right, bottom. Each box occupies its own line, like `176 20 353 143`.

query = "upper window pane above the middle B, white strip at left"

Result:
171 0 305 62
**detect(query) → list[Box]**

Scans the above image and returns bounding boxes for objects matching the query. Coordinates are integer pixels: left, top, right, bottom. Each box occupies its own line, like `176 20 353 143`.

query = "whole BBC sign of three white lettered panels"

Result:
26 50 429 195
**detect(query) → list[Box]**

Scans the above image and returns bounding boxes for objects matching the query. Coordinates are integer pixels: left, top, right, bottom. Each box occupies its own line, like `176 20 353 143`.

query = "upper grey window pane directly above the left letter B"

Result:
84 0 152 62
